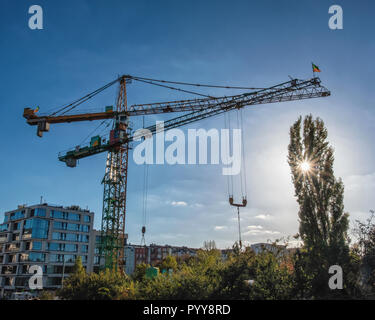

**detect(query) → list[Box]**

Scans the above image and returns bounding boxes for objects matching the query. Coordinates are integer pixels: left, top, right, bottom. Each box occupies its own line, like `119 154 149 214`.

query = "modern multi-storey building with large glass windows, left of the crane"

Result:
0 204 96 295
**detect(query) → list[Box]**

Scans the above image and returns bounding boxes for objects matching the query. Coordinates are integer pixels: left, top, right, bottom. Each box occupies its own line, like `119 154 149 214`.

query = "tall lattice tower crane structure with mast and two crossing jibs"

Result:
23 75 330 270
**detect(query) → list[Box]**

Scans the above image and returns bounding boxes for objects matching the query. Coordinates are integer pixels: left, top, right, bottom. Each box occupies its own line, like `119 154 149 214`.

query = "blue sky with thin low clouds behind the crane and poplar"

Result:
0 0 375 247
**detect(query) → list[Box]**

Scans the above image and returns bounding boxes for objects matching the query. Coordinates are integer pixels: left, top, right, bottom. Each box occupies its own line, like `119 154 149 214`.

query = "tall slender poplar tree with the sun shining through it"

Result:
288 115 349 297
